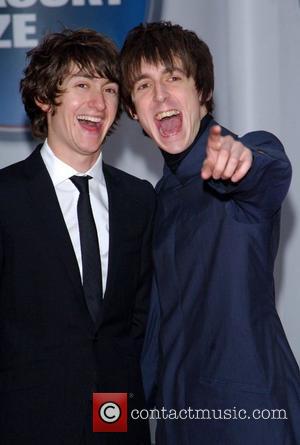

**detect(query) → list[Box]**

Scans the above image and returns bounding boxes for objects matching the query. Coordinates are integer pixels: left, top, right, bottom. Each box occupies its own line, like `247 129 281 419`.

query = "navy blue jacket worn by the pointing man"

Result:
143 121 300 445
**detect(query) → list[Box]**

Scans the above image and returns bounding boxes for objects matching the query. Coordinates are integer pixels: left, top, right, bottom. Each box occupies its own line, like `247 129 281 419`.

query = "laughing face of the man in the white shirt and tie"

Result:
38 66 119 171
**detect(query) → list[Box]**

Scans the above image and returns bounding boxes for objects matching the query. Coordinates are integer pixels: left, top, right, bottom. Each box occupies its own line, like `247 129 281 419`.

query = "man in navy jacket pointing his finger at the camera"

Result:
121 22 300 445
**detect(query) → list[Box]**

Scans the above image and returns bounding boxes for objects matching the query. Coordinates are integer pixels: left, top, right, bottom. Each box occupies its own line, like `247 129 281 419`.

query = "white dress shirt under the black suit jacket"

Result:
41 139 109 296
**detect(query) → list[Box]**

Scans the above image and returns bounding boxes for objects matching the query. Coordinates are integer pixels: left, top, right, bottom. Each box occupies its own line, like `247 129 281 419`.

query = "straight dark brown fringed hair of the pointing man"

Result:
120 21 214 117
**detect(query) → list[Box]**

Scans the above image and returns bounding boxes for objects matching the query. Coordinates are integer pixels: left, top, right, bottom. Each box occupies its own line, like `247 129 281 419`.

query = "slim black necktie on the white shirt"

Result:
70 176 102 322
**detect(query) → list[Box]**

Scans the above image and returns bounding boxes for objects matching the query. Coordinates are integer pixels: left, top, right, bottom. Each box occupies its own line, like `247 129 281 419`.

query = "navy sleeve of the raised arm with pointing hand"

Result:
208 131 292 219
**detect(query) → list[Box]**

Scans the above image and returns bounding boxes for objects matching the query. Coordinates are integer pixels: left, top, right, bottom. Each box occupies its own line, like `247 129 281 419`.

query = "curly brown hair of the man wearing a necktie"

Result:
20 29 121 139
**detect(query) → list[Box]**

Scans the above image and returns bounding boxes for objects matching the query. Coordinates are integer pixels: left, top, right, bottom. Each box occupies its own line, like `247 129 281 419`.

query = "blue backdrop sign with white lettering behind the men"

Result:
0 0 155 131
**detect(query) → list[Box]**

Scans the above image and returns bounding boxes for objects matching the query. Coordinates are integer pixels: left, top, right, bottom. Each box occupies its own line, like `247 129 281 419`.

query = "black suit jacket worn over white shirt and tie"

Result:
0 148 155 445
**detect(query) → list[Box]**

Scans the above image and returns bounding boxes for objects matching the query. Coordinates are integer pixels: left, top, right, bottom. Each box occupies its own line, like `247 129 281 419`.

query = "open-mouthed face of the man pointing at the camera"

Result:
131 60 207 154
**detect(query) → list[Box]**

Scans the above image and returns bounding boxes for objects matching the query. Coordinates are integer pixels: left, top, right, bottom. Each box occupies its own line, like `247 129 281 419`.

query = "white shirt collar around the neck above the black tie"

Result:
41 139 105 187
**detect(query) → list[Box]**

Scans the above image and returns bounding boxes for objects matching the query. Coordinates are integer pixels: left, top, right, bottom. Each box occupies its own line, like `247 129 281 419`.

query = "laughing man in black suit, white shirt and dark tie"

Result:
0 29 155 445
